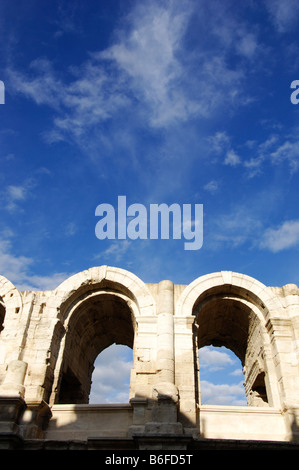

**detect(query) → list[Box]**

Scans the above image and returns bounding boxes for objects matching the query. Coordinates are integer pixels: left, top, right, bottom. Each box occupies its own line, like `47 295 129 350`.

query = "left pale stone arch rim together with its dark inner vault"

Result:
47 266 156 403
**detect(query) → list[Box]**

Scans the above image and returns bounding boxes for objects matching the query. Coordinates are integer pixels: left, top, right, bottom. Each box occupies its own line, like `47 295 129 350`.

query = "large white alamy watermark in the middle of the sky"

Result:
95 196 203 250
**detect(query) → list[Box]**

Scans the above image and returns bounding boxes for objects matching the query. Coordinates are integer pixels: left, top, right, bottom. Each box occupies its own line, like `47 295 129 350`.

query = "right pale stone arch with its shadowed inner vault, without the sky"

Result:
177 271 284 406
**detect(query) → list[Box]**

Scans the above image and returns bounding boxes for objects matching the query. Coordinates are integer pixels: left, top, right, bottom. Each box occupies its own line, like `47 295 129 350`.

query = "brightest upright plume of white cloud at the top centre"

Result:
98 2 199 127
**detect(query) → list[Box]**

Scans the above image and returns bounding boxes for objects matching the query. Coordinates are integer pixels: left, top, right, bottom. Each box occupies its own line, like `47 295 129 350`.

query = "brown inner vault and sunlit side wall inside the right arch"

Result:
193 289 268 406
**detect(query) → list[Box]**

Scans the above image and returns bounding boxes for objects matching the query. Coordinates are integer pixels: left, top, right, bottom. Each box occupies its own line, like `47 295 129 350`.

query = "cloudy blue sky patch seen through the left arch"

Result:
89 344 133 404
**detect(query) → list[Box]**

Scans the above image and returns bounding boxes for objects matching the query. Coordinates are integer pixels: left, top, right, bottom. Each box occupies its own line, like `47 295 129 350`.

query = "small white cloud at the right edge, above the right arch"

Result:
260 220 299 253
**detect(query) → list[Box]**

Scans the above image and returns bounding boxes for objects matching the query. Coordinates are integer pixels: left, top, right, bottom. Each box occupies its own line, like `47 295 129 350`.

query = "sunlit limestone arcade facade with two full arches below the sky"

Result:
0 266 299 449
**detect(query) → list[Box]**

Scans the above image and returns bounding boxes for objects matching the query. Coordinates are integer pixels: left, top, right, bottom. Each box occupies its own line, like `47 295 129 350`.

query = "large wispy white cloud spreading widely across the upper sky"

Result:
7 0 256 147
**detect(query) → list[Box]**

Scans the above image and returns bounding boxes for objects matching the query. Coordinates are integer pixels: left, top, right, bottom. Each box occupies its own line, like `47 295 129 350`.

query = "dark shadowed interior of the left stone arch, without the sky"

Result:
55 292 135 404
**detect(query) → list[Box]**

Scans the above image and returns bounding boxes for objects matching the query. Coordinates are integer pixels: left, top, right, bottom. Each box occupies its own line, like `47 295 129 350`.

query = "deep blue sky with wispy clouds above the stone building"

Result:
0 0 299 404
